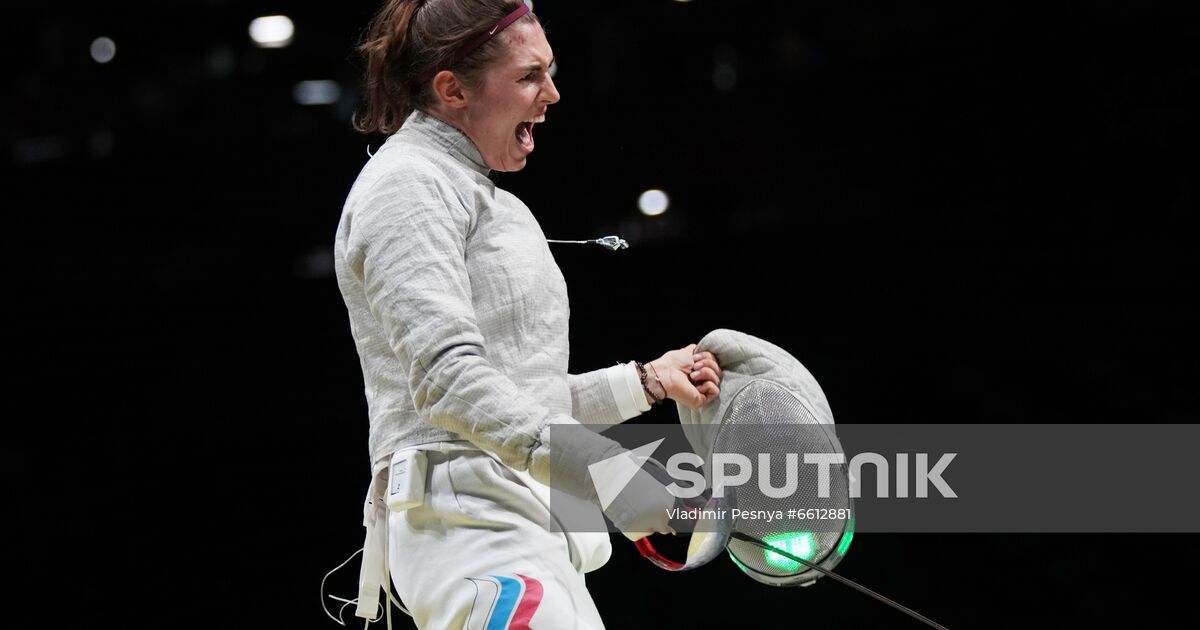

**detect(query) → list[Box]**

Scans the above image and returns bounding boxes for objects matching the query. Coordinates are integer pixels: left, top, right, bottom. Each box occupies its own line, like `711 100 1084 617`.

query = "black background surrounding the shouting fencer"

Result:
7 0 1200 628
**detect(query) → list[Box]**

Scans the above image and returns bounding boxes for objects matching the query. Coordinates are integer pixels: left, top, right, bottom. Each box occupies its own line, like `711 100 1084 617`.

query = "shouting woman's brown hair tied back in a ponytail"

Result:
354 0 538 133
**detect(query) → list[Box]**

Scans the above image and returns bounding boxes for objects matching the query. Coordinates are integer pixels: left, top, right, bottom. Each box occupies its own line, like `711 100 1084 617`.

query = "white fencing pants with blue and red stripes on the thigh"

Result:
388 444 612 630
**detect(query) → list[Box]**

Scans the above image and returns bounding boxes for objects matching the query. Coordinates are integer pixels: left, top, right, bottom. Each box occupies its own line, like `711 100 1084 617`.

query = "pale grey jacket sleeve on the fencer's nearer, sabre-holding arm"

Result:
346 172 623 499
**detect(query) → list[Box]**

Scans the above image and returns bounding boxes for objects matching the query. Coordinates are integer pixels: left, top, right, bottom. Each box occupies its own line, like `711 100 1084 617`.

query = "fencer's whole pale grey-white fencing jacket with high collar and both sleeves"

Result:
334 112 649 498
